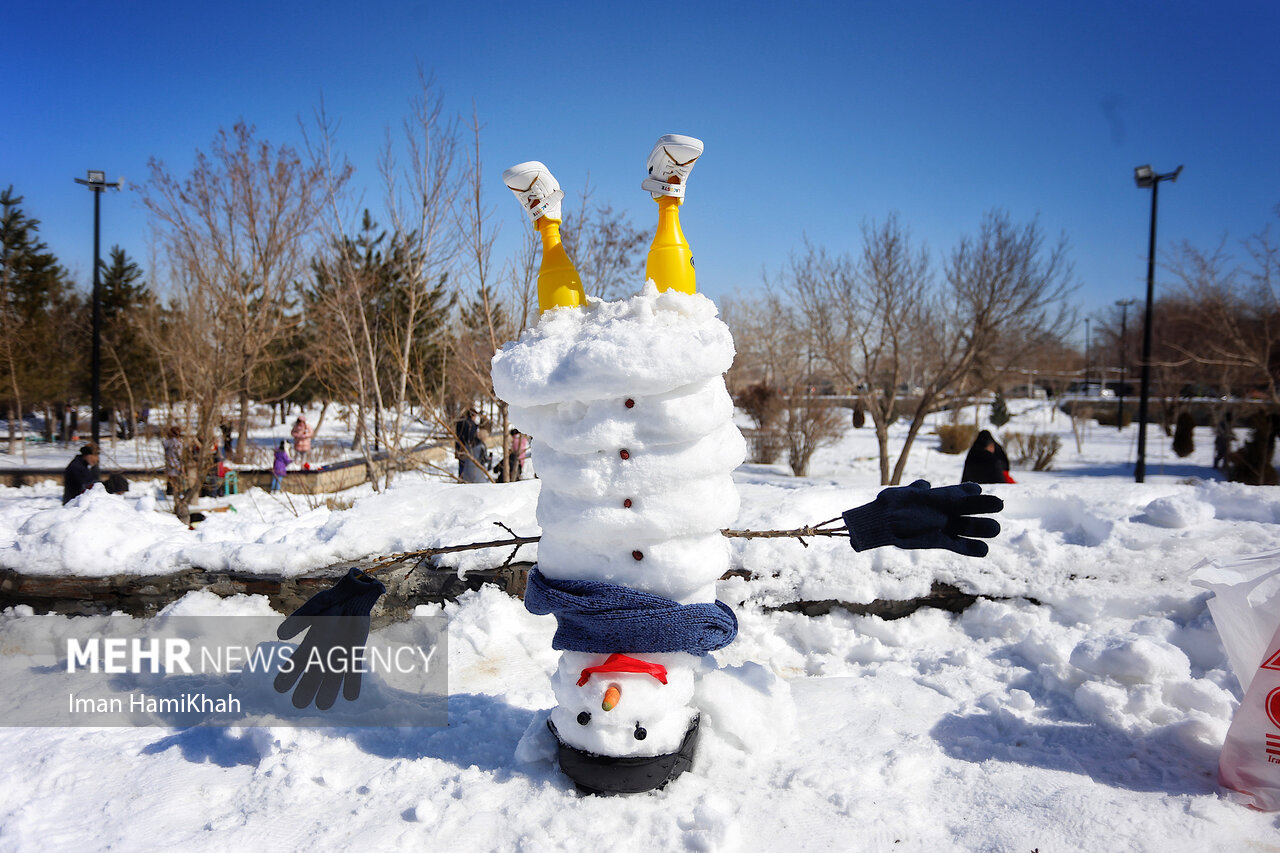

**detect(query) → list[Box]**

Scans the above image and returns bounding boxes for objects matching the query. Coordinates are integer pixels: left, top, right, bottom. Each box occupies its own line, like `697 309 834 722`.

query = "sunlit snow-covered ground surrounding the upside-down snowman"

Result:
0 402 1280 853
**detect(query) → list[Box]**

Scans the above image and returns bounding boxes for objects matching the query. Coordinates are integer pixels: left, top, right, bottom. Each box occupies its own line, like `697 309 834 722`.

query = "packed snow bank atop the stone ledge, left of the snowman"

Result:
0 476 539 576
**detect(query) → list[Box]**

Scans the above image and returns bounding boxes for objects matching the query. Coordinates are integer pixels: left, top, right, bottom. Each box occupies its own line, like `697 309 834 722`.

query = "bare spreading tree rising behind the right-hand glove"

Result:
762 211 1073 484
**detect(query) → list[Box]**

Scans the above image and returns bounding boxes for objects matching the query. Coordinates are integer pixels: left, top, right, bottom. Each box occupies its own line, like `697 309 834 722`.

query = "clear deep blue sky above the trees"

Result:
10 0 1280 342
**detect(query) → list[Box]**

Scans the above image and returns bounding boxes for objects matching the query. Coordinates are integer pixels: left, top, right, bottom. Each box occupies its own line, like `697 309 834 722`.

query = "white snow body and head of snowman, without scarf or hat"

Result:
493 283 746 756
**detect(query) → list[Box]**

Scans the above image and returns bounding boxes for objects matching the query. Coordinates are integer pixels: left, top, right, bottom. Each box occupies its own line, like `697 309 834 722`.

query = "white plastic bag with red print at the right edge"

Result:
1192 551 1280 812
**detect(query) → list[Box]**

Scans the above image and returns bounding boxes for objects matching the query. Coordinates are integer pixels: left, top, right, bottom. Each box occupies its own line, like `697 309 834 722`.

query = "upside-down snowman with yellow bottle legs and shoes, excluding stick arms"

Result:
493 134 745 793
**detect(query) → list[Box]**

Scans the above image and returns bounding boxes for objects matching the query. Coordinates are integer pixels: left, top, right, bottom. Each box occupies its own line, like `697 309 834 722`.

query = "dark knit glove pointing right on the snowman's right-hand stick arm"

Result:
842 480 1005 557
